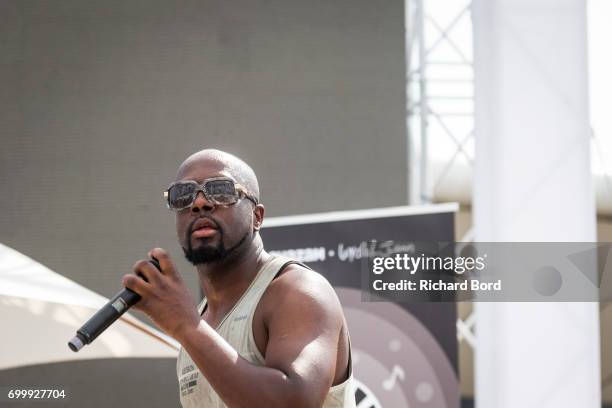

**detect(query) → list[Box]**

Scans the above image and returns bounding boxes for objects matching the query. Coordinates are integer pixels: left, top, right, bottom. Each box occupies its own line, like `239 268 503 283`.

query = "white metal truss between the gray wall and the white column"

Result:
405 0 474 204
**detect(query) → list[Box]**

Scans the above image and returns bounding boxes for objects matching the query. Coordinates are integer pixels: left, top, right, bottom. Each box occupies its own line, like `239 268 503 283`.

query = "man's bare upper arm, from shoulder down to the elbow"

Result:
266 274 342 398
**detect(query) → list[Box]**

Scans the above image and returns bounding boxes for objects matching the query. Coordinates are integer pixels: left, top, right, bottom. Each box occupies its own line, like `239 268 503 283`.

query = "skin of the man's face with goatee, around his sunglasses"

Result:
176 160 254 265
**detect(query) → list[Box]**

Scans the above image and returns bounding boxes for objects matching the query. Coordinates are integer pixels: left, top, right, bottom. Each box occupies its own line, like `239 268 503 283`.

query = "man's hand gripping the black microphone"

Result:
123 248 200 340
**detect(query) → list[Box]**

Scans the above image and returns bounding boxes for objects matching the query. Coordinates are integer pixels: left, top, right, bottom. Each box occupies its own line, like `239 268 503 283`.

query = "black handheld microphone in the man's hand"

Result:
68 258 161 353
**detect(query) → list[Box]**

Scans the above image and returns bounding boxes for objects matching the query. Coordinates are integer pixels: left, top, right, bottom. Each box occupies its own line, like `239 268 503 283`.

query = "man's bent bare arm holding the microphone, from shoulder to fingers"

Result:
124 248 343 408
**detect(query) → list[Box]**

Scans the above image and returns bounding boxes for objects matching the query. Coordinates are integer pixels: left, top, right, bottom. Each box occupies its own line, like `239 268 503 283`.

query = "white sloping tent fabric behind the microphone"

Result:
0 244 179 369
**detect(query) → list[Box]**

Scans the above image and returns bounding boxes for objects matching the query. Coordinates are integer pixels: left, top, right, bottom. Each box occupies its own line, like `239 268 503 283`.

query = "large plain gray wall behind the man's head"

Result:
0 0 407 312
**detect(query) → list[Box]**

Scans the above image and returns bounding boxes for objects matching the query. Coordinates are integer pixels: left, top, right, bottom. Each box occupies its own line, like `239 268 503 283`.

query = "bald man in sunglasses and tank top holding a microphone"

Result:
123 150 355 408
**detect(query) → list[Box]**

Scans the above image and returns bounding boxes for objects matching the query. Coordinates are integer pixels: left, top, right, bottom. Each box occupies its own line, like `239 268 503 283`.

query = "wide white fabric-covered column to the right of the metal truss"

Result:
472 0 601 408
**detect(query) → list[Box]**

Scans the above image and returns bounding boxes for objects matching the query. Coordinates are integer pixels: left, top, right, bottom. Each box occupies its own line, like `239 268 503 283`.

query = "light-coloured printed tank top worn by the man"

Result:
176 256 355 408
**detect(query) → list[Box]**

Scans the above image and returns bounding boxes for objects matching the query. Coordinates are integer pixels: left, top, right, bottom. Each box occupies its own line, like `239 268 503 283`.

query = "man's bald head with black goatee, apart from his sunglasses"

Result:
170 149 264 265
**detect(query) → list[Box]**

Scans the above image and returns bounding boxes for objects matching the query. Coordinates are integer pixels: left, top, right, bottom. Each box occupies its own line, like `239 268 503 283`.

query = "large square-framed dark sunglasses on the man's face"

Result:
164 177 258 211
